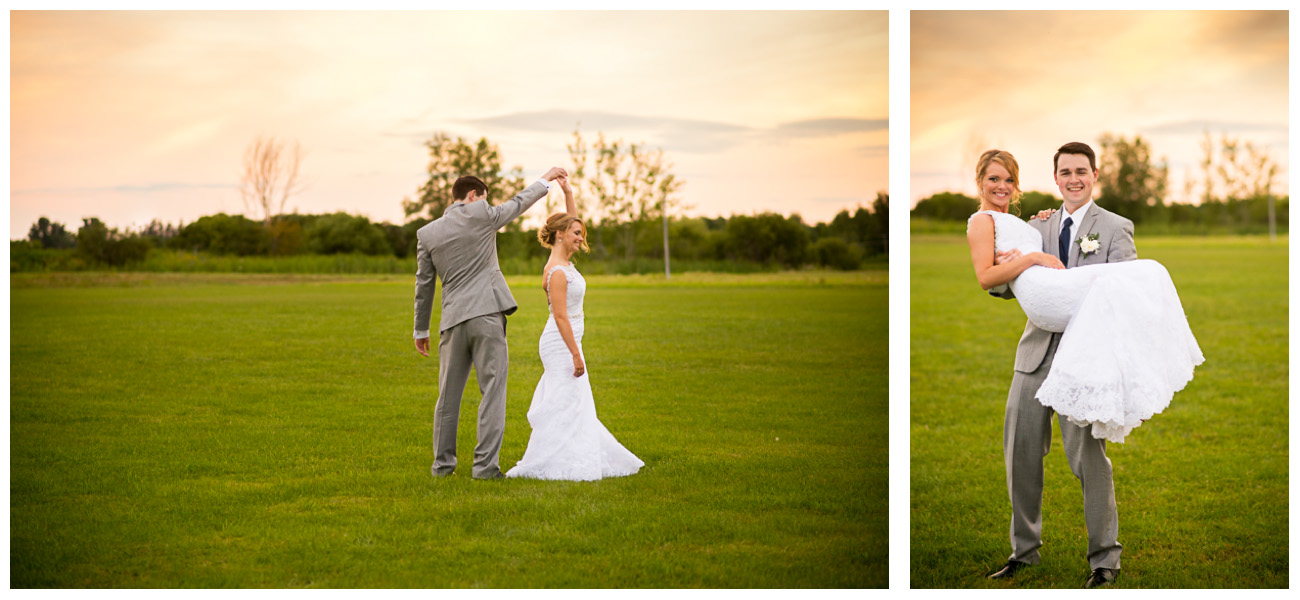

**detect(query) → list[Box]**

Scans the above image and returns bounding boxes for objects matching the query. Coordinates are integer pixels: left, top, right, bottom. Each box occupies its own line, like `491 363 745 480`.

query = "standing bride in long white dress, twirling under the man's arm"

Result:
506 178 645 481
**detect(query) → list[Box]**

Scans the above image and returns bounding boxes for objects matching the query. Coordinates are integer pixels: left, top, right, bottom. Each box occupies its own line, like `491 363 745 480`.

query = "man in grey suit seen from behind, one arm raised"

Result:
415 166 567 479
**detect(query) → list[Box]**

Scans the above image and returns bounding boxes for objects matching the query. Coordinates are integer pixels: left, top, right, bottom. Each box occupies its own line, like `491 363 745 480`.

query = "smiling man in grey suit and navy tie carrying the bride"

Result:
988 142 1138 588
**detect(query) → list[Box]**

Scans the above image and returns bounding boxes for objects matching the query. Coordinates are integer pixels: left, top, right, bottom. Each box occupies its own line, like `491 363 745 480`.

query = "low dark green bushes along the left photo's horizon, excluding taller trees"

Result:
9 205 888 271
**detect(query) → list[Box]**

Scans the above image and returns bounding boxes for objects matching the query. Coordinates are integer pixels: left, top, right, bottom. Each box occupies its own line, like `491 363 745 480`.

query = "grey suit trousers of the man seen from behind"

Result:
433 313 510 479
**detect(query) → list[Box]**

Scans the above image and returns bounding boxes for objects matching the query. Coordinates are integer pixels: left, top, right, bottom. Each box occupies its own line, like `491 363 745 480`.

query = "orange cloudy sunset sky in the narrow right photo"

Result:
910 10 1290 204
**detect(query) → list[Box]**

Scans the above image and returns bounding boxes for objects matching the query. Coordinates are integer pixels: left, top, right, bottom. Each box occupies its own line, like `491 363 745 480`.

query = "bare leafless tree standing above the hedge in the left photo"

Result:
239 136 303 230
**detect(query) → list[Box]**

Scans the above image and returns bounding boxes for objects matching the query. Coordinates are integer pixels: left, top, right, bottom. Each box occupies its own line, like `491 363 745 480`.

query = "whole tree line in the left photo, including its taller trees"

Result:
10 131 889 271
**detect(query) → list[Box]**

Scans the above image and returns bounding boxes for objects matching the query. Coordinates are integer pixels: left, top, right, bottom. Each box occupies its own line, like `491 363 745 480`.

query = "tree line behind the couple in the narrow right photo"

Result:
911 134 1290 234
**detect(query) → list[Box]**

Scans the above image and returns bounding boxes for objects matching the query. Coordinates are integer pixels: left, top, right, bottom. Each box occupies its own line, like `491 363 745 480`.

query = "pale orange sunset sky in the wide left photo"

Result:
9 12 889 239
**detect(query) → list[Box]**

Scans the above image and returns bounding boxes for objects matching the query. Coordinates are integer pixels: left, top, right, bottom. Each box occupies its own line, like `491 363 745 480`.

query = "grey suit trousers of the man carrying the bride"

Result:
1002 334 1122 569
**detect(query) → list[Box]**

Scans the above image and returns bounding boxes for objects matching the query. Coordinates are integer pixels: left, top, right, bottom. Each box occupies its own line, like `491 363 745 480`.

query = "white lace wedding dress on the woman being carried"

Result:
971 210 1205 442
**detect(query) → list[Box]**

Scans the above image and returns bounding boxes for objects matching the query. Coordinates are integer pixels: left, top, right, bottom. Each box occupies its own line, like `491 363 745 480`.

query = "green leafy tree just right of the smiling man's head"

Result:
1097 134 1169 223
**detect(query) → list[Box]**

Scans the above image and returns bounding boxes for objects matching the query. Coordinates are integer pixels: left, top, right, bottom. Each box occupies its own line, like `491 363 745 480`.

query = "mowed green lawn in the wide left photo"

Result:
9 271 888 587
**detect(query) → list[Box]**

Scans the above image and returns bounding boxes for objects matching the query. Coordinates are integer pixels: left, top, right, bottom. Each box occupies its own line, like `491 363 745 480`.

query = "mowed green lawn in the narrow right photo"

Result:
911 233 1288 588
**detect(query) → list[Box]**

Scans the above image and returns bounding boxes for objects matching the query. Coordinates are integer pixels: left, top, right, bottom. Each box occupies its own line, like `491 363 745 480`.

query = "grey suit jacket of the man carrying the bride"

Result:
989 203 1138 373
